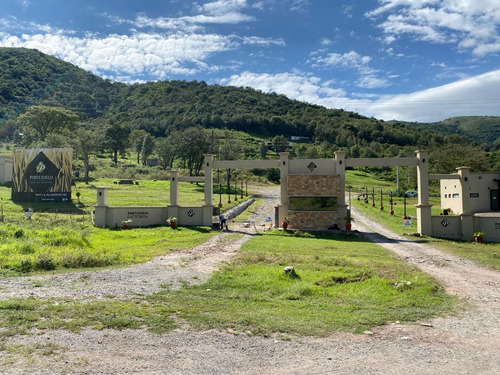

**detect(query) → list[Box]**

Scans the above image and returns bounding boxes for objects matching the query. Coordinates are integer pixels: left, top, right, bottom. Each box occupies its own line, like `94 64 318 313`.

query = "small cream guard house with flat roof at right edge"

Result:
440 167 500 215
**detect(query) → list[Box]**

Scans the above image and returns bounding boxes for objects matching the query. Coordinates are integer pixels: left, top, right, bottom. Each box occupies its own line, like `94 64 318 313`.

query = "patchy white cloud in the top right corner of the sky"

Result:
366 0 500 56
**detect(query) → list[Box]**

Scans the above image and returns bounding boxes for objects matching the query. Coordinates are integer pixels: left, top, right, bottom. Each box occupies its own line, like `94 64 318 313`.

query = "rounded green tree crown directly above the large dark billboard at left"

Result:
19 106 78 146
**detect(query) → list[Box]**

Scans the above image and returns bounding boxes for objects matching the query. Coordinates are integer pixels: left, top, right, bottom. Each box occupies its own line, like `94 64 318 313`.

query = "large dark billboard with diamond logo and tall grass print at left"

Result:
12 148 73 202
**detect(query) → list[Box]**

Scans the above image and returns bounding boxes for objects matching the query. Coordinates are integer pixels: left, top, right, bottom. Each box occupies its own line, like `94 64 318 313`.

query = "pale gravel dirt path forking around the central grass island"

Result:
0 192 500 375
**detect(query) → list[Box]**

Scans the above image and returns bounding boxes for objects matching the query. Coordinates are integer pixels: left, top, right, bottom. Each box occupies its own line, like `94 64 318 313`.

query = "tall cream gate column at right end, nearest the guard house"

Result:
415 150 432 236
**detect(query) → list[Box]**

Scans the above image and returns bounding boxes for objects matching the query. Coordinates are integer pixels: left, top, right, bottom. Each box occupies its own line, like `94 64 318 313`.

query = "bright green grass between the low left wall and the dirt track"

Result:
0 223 215 275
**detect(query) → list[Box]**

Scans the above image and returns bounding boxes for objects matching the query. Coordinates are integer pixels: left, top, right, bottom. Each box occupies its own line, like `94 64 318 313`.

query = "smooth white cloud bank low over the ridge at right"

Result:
220 70 500 122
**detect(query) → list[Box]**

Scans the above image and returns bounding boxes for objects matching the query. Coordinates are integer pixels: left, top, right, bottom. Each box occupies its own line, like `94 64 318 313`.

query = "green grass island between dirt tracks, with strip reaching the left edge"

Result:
0 232 457 342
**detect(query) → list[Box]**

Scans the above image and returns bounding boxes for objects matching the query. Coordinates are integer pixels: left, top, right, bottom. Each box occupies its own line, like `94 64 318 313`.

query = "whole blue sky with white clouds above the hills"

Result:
0 0 500 122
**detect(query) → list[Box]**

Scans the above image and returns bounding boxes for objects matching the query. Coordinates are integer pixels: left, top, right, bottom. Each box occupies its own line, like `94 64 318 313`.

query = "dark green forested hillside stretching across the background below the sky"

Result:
0 48 500 175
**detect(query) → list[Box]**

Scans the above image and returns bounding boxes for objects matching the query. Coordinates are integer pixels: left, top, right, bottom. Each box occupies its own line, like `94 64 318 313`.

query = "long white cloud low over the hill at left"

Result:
0 33 237 80
